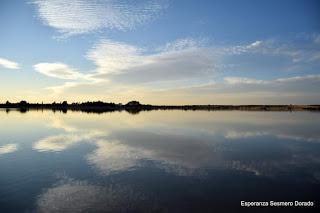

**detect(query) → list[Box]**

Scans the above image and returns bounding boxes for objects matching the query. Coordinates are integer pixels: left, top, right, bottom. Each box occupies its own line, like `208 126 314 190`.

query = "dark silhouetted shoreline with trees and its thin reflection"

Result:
0 101 320 114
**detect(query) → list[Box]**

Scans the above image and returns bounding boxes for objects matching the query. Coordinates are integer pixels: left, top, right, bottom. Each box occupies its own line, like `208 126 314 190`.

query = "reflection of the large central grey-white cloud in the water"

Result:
87 131 232 175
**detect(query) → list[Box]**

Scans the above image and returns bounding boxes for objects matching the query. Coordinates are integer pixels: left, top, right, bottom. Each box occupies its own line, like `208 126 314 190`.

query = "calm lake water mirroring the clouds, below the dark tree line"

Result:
0 110 320 212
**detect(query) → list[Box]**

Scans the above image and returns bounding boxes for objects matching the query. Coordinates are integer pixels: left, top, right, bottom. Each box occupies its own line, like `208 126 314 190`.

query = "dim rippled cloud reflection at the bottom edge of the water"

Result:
37 178 155 213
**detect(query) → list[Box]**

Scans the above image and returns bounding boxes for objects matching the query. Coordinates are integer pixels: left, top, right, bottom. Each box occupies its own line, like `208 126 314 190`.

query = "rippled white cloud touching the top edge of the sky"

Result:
33 0 167 35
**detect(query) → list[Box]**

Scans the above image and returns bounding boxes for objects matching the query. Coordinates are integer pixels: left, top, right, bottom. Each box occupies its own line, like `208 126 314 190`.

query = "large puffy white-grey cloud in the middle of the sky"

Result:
87 39 215 83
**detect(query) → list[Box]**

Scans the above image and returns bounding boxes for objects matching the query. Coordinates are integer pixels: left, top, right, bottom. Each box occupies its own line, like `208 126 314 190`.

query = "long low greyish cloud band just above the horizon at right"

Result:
175 75 320 104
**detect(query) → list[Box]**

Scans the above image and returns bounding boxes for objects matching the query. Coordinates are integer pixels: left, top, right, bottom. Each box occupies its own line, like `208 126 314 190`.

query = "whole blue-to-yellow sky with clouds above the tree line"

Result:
0 0 320 104
